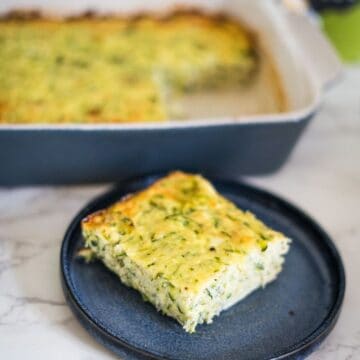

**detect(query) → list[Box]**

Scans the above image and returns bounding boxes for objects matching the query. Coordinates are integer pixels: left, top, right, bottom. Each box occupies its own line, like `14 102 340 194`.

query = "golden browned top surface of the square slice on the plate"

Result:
82 172 283 291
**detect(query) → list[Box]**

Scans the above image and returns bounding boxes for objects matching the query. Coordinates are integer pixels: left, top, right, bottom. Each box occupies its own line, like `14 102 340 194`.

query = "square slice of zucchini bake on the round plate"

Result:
80 172 290 332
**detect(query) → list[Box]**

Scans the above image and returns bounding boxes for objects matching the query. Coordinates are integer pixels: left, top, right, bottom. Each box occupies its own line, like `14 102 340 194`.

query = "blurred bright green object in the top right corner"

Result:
321 3 360 63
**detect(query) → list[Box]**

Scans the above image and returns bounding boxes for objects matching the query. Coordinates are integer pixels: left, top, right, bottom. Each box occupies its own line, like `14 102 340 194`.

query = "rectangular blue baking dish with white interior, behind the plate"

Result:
0 0 341 185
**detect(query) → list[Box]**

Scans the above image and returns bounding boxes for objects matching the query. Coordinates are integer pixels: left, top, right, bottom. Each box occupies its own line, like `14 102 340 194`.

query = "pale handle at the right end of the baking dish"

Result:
286 11 343 90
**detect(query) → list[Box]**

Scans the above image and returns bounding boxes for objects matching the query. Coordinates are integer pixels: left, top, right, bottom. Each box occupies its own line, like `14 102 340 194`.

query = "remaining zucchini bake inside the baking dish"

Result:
0 12 257 123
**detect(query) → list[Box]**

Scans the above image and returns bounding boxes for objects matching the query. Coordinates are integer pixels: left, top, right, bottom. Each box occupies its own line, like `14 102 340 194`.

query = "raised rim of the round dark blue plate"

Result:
60 172 346 360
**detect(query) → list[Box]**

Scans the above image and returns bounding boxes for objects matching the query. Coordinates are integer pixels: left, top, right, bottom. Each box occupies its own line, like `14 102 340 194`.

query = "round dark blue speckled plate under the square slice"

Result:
61 176 345 360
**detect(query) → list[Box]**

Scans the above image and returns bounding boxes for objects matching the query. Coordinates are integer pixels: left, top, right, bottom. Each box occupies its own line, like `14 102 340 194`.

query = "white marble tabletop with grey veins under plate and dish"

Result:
0 68 360 360
